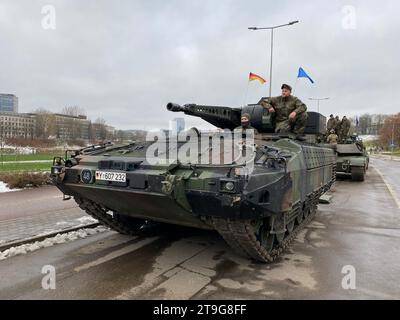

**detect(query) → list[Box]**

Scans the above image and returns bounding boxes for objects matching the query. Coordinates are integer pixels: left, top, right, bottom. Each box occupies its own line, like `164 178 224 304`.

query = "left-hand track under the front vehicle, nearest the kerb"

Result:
74 197 143 235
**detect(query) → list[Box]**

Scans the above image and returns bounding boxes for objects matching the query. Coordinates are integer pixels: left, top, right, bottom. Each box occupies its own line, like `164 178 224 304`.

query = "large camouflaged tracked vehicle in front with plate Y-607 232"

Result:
52 103 336 262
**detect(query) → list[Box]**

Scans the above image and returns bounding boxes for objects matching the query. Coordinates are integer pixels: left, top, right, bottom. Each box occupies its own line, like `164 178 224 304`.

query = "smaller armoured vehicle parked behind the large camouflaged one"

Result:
336 136 369 181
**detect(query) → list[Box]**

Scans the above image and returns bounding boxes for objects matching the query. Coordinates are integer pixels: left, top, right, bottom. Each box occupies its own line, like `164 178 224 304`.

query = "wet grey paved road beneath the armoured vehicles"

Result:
0 159 400 299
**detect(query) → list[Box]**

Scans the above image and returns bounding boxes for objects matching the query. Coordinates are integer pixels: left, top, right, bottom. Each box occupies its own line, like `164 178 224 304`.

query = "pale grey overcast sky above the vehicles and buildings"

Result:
0 0 400 129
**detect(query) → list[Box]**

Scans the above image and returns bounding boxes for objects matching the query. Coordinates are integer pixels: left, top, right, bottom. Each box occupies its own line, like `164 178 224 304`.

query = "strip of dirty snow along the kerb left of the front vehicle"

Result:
0 226 108 261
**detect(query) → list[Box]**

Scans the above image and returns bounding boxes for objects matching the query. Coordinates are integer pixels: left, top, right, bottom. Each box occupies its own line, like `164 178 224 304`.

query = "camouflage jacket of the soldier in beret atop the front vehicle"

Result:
261 96 307 123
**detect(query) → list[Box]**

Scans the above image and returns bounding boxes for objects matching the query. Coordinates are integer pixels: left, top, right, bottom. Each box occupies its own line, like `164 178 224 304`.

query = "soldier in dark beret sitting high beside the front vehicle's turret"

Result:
261 84 307 135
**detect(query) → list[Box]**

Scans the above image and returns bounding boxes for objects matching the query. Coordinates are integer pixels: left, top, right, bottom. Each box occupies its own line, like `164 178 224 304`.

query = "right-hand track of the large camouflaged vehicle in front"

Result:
211 189 324 263
